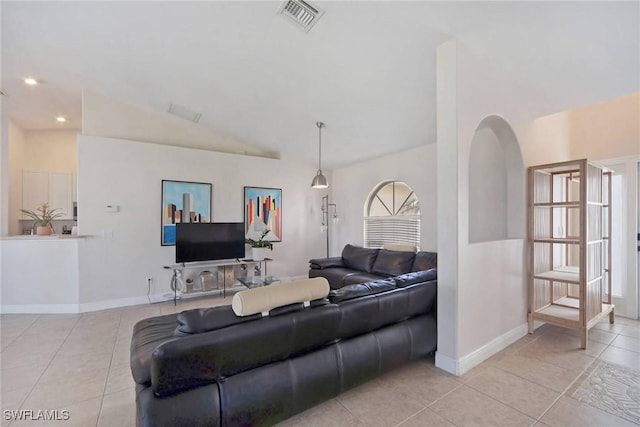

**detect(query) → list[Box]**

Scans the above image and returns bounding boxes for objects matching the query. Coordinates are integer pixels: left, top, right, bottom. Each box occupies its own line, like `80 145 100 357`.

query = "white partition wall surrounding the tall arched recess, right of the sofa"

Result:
436 40 569 373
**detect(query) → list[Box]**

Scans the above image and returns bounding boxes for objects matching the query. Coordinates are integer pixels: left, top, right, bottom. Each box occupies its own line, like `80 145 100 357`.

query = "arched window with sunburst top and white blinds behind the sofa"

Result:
364 181 420 249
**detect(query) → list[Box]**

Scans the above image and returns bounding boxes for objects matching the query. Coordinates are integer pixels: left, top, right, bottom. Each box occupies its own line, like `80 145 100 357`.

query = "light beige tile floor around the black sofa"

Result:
0 297 640 427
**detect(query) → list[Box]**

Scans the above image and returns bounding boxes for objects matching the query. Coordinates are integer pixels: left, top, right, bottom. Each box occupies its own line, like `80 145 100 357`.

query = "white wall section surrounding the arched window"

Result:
330 144 438 256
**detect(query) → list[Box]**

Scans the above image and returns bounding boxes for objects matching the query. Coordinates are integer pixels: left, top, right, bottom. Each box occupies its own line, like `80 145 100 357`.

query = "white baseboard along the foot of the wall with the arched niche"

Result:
436 322 529 375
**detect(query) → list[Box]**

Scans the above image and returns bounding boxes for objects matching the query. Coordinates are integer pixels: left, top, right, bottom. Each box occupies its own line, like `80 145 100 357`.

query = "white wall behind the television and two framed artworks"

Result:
78 135 324 308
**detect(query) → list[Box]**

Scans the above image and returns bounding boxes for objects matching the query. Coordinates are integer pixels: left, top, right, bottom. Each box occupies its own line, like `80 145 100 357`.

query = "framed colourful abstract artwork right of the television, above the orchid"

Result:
244 187 282 242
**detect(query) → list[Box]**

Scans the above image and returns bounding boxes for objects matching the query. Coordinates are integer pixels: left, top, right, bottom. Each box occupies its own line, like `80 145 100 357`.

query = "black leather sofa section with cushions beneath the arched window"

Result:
309 245 438 289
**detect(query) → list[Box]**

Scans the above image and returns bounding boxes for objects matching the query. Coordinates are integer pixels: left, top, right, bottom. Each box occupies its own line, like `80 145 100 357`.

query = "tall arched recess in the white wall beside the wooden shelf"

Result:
469 115 526 243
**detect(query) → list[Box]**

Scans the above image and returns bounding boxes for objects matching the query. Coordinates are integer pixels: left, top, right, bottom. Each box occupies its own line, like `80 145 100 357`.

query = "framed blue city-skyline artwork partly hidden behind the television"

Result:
160 179 212 246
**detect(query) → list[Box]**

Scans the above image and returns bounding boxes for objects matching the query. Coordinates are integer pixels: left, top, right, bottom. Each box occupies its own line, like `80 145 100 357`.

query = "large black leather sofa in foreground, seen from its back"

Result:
131 269 437 427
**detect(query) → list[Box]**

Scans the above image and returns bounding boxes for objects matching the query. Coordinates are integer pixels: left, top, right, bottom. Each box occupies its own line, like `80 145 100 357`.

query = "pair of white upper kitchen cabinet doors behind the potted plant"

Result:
22 171 74 219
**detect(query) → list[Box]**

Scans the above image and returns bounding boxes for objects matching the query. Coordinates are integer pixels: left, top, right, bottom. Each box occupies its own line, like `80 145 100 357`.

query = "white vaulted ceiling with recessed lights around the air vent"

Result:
0 1 640 168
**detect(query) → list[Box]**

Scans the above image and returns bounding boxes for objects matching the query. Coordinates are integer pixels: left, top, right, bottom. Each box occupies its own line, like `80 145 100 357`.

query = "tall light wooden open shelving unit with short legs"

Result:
528 160 614 348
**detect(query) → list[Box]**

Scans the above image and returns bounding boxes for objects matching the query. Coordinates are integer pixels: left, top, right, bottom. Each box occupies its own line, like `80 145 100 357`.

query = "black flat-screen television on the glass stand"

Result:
176 222 244 263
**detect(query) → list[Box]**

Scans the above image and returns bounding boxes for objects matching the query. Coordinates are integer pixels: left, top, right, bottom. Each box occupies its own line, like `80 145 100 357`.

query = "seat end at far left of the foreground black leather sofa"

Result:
130 314 177 385
